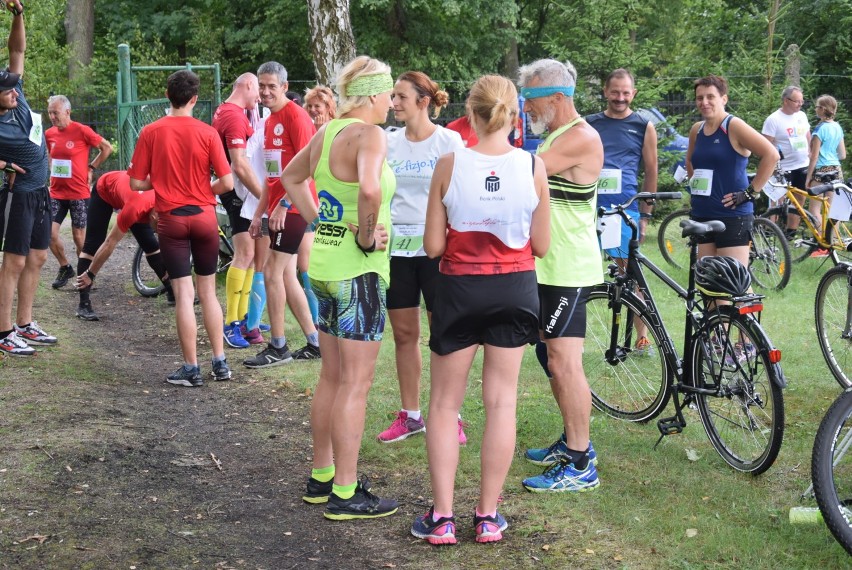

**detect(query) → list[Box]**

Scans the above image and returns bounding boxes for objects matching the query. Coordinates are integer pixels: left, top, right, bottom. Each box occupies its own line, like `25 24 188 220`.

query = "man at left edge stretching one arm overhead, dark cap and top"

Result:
0 0 56 356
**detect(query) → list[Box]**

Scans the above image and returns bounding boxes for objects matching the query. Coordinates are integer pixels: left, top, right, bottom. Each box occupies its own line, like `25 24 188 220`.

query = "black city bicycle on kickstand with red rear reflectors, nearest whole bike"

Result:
583 192 785 475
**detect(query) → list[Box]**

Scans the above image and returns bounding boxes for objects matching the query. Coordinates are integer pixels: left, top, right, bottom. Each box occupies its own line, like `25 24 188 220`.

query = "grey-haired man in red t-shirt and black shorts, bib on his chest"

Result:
44 95 112 289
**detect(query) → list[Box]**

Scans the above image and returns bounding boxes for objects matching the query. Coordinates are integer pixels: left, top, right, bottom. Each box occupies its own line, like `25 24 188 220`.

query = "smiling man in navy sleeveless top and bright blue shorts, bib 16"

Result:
586 69 657 255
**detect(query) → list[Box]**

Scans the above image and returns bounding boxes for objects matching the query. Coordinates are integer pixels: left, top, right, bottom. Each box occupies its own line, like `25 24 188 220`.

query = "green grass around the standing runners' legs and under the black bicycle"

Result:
5 224 852 568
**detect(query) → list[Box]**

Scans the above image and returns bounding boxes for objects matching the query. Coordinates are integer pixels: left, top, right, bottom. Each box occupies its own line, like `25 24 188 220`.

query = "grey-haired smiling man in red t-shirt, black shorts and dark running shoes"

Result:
243 61 319 368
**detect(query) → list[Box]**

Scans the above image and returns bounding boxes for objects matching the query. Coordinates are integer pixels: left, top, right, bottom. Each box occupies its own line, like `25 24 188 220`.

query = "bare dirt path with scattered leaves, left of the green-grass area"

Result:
0 240 419 569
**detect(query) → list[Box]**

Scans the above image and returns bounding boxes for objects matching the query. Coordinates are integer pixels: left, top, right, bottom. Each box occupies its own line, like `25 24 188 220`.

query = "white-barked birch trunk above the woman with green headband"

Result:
308 0 355 85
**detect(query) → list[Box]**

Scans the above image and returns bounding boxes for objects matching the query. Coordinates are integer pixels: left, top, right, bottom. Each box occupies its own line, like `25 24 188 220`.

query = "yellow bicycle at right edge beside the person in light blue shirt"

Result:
760 168 852 265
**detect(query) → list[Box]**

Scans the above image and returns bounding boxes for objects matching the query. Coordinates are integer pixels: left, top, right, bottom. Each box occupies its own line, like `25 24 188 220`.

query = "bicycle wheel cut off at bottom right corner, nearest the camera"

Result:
811 391 852 554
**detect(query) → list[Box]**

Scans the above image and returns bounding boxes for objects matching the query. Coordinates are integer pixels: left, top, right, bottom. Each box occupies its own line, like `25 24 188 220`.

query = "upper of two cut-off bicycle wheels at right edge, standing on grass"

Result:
814 264 852 388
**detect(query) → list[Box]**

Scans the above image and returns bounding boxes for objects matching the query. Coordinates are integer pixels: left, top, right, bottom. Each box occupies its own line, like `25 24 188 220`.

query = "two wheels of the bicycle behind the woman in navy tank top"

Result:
657 208 791 291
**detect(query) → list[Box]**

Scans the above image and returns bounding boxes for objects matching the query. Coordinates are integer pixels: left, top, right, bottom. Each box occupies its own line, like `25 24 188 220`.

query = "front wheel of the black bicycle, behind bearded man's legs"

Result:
583 284 670 422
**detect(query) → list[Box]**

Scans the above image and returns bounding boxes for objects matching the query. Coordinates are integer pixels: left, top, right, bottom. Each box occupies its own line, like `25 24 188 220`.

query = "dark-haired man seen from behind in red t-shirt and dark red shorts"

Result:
127 69 234 387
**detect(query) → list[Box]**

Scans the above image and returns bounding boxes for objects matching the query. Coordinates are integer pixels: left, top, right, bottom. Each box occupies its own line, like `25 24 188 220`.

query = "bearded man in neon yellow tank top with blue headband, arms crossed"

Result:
519 59 604 492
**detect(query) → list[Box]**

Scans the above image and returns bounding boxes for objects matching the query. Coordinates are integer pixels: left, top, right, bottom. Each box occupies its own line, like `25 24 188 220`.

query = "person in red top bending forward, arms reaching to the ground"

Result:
77 170 174 321
